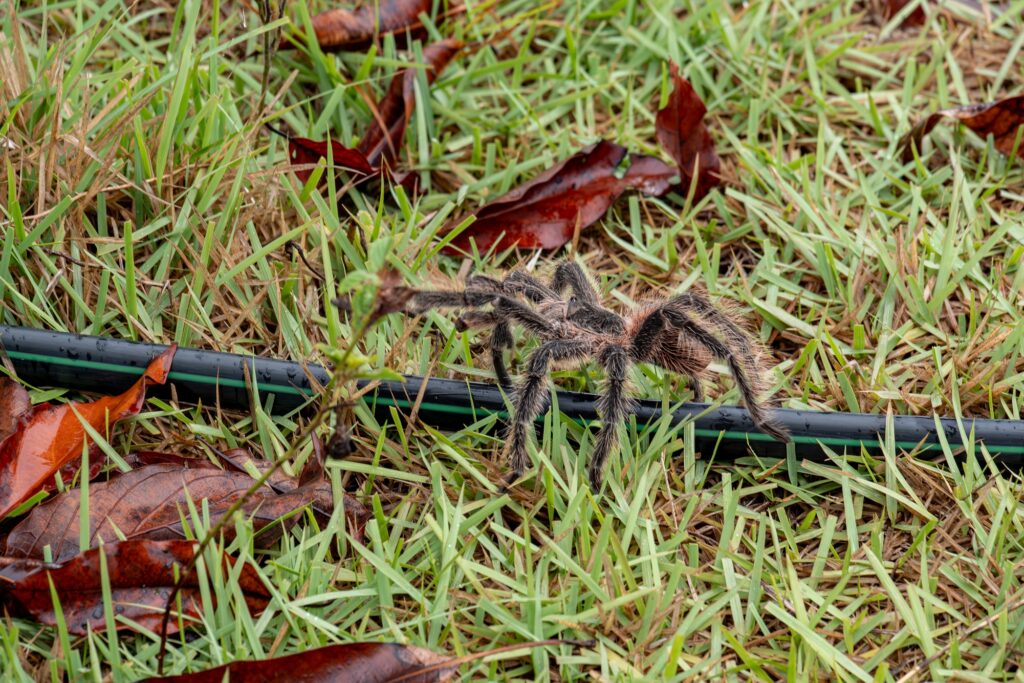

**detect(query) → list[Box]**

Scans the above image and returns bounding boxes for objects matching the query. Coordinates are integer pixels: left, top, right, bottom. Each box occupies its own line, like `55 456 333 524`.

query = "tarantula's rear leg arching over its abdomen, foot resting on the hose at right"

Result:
632 305 790 441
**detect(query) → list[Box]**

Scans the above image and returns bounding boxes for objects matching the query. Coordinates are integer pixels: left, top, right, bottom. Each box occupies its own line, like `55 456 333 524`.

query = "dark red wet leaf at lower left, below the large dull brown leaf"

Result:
0 541 270 635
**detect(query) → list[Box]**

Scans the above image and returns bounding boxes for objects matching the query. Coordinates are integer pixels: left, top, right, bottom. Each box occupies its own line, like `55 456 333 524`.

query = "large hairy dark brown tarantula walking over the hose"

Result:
408 260 788 493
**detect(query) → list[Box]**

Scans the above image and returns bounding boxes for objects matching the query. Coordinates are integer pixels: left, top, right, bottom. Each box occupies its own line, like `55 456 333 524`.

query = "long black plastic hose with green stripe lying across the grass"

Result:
0 326 1024 468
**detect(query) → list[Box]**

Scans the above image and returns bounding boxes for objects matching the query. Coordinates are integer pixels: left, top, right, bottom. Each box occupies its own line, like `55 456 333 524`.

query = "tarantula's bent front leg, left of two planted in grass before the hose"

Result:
505 339 591 485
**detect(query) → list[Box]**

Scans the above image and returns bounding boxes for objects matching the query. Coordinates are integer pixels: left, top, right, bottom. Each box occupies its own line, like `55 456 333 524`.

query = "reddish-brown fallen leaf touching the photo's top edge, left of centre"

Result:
279 0 431 52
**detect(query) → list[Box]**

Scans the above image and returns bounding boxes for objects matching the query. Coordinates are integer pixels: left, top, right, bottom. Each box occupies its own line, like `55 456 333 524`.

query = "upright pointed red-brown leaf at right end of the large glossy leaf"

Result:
654 63 722 200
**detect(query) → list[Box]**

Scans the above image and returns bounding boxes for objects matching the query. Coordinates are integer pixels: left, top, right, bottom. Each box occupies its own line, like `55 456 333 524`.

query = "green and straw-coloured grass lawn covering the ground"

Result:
0 0 1024 681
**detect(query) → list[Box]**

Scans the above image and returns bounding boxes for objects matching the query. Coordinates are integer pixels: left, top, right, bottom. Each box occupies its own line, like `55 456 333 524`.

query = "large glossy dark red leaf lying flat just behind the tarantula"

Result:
444 140 679 254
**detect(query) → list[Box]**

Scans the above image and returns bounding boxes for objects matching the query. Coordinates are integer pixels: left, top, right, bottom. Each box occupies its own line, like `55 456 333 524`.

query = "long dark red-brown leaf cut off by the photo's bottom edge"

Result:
150 643 456 683
